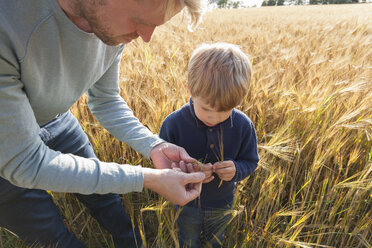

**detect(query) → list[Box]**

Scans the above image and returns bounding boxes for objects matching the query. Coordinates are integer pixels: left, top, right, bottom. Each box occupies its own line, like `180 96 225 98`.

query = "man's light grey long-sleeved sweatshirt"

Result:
0 0 162 194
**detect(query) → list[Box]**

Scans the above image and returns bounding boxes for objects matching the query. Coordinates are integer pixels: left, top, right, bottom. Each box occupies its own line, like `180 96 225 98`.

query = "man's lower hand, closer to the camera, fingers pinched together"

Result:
142 168 205 206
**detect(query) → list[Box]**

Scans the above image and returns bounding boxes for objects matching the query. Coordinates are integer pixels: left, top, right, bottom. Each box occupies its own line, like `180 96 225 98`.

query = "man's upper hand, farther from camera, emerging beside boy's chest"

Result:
150 142 196 169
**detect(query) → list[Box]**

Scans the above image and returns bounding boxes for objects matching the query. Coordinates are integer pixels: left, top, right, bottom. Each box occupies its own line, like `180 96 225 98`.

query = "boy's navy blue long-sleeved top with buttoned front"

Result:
159 98 259 209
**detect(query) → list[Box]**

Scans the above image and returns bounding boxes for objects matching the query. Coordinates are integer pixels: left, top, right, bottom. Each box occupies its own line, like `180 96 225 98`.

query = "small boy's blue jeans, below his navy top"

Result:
177 205 231 248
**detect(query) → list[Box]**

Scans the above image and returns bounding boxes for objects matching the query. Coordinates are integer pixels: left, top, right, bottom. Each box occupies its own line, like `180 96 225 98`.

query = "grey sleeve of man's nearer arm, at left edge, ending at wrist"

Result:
0 39 143 194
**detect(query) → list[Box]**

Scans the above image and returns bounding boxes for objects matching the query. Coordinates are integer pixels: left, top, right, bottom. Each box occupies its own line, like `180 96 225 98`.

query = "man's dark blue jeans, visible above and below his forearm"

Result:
0 112 142 248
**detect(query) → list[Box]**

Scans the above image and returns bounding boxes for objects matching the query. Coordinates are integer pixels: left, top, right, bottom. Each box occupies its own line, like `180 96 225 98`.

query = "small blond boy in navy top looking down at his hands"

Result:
160 43 259 247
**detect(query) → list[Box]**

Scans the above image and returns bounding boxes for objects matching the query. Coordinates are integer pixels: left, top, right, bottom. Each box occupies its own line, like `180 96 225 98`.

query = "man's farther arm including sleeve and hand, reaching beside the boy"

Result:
88 52 195 169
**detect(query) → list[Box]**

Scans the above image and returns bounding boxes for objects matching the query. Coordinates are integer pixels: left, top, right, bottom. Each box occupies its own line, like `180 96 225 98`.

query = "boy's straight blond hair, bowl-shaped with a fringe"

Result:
188 43 252 111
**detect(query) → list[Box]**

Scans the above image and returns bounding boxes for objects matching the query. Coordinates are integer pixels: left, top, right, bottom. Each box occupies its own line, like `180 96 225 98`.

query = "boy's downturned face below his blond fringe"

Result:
192 96 232 127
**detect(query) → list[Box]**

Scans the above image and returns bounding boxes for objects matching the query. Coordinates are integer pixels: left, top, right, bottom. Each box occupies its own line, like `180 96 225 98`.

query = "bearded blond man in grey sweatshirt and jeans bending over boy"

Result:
0 0 204 248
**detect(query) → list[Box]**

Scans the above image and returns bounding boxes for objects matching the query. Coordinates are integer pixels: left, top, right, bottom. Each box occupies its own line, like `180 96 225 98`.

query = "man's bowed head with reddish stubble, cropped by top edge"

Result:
58 0 204 46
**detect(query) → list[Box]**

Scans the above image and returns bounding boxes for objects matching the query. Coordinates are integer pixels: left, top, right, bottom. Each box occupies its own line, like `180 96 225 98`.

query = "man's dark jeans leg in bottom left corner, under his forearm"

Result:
0 184 83 247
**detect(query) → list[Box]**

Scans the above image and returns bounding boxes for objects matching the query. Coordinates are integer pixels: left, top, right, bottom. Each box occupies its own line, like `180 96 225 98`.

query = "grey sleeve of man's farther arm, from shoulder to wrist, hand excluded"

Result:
87 54 164 158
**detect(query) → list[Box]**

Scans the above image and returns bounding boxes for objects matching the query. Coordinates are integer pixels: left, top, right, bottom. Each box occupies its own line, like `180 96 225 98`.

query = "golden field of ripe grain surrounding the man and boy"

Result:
0 4 372 248
